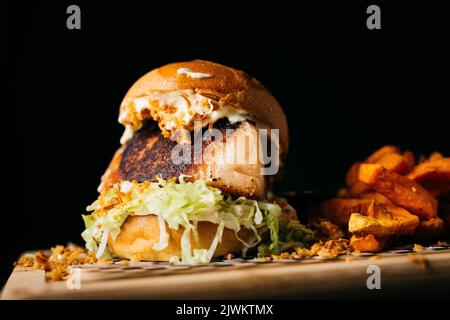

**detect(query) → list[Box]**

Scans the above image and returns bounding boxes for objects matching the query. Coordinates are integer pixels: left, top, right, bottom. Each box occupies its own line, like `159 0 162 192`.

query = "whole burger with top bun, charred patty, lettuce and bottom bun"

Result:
82 60 312 263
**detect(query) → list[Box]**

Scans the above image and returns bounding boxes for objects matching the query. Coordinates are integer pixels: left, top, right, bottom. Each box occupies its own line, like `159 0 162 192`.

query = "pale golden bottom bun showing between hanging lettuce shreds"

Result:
108 215 254 261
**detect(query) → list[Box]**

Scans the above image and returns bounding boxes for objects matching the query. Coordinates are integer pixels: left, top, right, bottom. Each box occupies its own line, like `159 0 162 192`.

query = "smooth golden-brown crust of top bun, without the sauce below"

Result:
119 60 289 160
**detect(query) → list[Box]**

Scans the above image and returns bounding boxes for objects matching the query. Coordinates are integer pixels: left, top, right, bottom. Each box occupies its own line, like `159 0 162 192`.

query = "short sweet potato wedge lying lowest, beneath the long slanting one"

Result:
348 202 420 237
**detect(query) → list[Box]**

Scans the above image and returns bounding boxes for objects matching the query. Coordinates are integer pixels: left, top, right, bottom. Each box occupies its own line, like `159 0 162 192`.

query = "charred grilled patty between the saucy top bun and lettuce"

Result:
101 119 266 199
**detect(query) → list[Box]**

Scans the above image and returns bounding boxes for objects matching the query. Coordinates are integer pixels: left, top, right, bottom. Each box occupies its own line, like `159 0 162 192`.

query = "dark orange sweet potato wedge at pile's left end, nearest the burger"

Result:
320 198 372 229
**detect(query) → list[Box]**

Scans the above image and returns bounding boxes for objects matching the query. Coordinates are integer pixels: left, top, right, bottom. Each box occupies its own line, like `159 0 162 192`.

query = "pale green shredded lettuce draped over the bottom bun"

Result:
82 177 281 263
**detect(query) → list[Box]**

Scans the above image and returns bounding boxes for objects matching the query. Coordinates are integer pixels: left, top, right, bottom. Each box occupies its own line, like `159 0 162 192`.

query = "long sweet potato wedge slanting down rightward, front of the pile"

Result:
358 163 437 219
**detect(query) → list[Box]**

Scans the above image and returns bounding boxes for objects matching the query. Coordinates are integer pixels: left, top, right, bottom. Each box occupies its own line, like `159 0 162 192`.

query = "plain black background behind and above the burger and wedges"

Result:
6 1 450 284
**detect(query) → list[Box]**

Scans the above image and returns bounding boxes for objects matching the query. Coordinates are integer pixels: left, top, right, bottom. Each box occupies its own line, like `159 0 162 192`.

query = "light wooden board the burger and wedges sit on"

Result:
1 248 450 299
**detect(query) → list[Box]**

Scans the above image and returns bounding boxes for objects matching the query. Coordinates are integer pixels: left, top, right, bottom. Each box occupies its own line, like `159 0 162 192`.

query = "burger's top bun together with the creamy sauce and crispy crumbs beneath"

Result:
119 60 288 159
